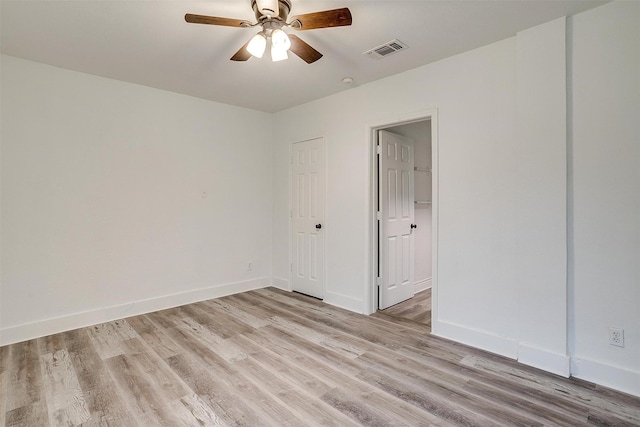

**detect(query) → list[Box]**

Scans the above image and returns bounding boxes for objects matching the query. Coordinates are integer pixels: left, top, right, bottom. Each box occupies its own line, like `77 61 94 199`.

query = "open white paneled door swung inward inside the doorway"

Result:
378 130 416 310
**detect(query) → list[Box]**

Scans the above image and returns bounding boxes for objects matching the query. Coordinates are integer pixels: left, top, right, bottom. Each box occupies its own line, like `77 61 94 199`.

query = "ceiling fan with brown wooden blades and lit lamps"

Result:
184 0 352 64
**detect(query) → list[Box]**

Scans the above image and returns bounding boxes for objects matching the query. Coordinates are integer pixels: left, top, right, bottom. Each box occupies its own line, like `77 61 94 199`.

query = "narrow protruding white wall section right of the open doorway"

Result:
516 18 569 376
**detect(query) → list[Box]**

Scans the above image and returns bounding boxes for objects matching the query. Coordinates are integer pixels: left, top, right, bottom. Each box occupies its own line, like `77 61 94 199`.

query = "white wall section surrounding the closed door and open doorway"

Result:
274 39 517 338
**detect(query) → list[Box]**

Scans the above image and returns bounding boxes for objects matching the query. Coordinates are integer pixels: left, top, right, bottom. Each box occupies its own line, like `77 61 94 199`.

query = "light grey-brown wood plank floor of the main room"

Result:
0 288 640 427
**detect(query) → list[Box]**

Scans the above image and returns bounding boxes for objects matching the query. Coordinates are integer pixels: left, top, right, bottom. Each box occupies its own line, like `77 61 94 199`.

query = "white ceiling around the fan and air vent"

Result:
1 0 606 112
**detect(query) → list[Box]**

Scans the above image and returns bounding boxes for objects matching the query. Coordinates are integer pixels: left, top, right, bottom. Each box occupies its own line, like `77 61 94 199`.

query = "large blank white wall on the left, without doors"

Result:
0 56 272 344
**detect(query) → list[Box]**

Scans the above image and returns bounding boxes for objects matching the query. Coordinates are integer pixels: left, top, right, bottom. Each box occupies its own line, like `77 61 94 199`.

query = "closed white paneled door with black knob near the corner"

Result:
291 138 325 298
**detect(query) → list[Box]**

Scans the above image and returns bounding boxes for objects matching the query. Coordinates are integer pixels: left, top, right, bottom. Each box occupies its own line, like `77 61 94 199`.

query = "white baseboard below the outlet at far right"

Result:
571 357 640 397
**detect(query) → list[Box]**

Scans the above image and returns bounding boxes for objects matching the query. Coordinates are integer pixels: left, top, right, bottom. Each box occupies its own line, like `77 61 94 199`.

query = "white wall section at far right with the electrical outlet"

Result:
569 2 640 395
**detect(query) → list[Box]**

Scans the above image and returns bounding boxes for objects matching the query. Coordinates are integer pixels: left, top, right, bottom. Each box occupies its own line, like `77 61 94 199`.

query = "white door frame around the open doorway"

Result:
364 108 439 332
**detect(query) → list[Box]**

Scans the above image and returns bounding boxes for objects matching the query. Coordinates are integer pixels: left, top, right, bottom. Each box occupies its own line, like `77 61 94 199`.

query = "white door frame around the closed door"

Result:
287 134 328 298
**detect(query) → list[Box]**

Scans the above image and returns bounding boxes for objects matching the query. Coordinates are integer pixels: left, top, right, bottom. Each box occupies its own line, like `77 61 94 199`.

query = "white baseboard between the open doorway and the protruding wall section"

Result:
431 320 518 359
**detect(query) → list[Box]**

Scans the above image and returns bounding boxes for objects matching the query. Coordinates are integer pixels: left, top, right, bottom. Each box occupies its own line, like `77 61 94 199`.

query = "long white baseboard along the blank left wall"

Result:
0 277 271 346
